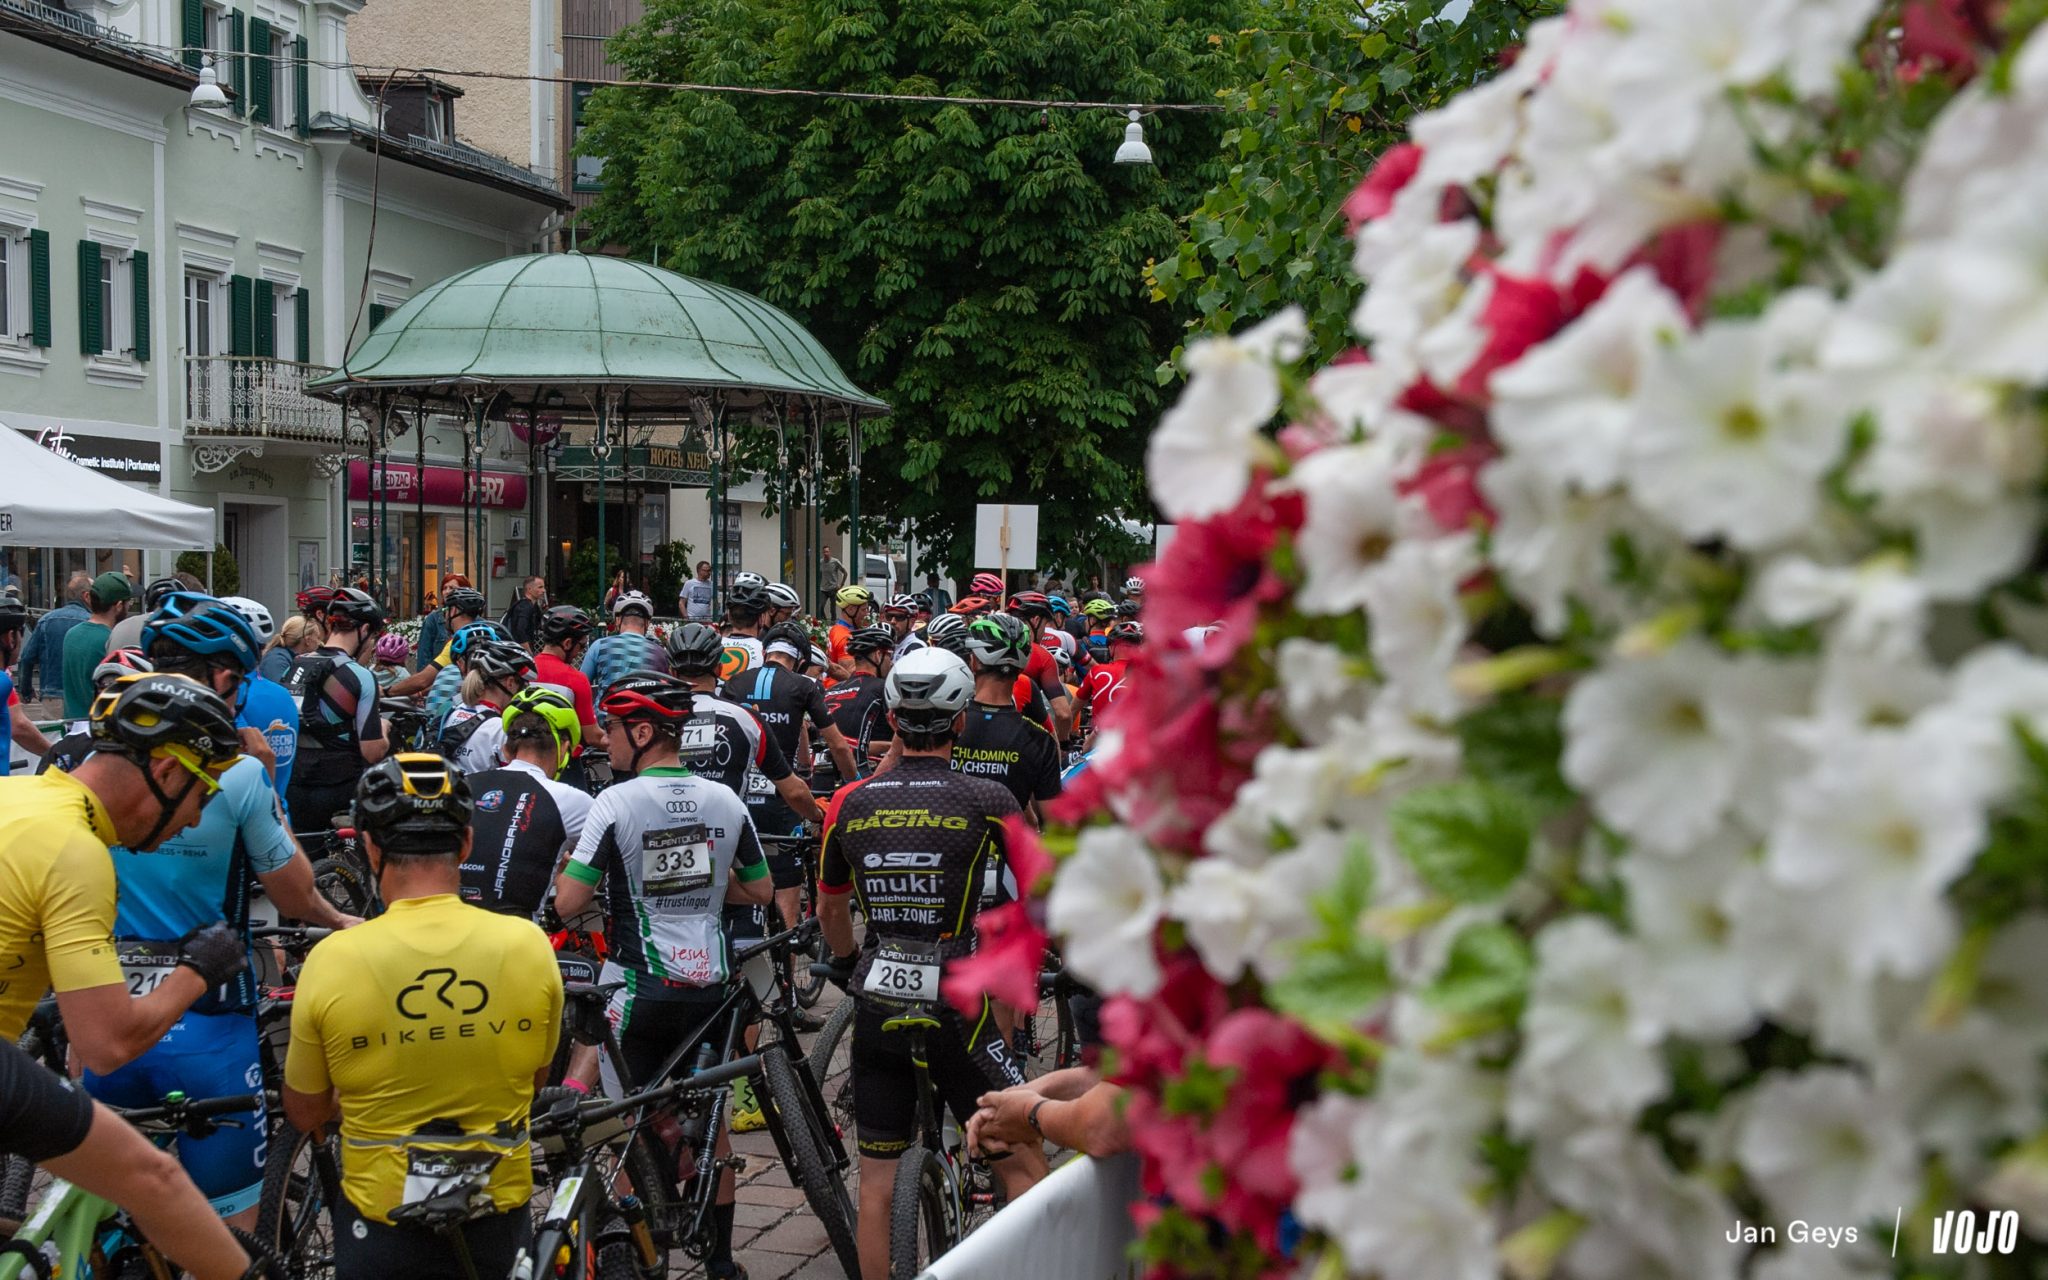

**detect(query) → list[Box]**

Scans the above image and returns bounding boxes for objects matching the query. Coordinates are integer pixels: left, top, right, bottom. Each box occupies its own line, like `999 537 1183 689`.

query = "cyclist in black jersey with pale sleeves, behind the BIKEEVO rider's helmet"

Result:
285 588 391 831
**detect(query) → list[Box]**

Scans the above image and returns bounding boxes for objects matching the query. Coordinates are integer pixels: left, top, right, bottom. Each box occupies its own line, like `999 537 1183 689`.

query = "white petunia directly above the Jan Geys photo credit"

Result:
1735 1067 1919 1223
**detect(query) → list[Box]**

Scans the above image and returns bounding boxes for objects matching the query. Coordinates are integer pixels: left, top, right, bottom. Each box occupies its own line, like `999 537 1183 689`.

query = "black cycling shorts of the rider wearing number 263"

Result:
852 999 1024 1159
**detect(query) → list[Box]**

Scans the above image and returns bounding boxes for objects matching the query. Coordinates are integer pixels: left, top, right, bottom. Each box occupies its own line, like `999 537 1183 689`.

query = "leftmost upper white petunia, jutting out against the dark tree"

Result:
1145 307 1309 520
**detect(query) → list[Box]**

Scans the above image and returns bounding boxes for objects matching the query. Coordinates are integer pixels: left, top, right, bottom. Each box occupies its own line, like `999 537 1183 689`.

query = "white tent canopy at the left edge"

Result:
0 426 213 551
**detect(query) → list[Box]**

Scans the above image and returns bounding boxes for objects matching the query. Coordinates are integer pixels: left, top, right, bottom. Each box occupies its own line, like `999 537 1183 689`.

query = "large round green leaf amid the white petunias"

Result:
1389 780 1532 903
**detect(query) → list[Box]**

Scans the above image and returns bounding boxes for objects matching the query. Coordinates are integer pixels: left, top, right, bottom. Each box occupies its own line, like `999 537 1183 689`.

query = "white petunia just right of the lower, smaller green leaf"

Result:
1507 915 1669 1135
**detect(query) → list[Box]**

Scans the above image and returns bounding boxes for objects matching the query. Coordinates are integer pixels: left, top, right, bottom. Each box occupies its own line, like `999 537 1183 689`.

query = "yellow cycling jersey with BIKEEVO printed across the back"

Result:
285 893 561 1223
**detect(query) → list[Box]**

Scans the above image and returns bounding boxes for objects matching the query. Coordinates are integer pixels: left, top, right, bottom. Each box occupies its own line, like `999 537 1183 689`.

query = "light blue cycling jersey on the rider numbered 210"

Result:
113 760 297 1014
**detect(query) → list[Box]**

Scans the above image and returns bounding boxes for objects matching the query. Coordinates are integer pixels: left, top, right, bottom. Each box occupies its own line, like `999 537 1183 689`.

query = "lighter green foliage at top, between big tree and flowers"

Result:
1149 0 1565 368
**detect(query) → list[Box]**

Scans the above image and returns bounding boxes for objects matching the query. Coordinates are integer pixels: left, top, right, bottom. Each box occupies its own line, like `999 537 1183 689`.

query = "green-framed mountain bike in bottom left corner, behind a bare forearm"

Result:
0 1092 283 1280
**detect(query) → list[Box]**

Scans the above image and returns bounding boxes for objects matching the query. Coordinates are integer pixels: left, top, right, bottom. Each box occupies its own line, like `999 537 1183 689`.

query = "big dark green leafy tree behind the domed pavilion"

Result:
582 0 1243 569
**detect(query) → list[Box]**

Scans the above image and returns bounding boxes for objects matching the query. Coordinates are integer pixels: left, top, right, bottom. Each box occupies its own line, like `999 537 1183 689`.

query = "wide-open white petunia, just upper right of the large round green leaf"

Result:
1565 641 1778 854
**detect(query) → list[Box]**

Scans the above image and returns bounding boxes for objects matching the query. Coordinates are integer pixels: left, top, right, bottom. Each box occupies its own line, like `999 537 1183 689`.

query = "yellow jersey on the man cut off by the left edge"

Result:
0 770 125 1040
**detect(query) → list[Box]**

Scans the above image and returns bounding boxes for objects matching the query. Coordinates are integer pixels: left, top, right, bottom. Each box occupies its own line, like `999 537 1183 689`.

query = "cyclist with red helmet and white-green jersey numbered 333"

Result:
555 672 770 1280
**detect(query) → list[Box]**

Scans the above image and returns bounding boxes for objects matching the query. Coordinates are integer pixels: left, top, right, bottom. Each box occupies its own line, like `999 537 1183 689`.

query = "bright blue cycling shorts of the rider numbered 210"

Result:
84 1014 268 1217
